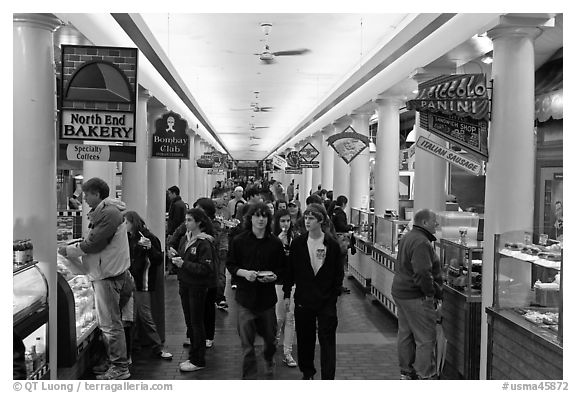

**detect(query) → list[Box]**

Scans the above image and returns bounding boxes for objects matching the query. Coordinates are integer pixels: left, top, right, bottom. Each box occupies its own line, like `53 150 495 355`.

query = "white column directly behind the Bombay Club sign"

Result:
145 100 168 249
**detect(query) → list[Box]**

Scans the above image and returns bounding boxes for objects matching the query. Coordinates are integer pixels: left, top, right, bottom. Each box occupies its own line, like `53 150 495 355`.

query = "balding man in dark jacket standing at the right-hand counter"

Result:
392 209 442 379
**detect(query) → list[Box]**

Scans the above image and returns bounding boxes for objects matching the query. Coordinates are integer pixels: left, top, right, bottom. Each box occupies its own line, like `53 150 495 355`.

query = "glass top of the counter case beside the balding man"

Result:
437 239 483 301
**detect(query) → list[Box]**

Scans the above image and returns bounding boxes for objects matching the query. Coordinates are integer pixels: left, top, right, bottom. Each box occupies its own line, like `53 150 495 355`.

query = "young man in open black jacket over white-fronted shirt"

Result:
283 203 344 379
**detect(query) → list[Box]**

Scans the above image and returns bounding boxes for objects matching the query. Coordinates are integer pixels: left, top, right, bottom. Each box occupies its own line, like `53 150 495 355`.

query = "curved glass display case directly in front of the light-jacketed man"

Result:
57 255 97 366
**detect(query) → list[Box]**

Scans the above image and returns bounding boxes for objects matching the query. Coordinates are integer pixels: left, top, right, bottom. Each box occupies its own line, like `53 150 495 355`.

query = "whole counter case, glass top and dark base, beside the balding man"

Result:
435 239 483 379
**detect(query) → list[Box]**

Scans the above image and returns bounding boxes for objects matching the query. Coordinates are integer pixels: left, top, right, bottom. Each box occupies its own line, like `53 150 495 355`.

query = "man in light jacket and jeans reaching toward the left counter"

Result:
58 177 133 380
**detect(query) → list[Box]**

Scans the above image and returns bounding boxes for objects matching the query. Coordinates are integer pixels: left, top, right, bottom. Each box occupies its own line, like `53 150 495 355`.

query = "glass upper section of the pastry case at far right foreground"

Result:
494 231 562 343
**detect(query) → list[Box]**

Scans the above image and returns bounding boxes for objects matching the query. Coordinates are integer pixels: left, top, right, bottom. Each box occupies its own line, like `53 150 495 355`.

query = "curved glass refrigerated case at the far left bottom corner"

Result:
12 261 49 379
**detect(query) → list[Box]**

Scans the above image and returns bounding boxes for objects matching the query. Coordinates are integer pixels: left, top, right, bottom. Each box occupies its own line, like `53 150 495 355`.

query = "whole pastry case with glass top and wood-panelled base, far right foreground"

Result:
486 231 563 380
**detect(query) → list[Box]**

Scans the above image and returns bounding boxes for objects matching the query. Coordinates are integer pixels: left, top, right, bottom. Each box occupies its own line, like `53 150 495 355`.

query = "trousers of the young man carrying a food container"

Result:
237 304 276 379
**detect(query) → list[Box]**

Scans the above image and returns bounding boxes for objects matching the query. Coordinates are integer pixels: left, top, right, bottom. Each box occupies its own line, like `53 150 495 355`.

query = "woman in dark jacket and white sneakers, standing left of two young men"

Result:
172 208 217 371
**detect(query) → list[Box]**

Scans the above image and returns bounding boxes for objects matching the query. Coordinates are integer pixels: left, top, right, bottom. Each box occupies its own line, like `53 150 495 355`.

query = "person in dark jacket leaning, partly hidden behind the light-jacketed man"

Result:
124 211 172 360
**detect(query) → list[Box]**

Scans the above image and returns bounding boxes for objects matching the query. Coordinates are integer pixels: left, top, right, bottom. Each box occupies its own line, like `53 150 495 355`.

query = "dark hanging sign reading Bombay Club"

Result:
152 111 190 160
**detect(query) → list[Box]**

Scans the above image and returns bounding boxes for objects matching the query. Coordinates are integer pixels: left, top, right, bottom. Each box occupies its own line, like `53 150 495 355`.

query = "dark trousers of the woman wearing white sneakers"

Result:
180 283 208 367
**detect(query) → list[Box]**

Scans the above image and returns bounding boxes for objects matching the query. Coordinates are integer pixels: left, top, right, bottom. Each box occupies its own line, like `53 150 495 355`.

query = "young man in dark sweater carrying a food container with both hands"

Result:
226 202 285 379
